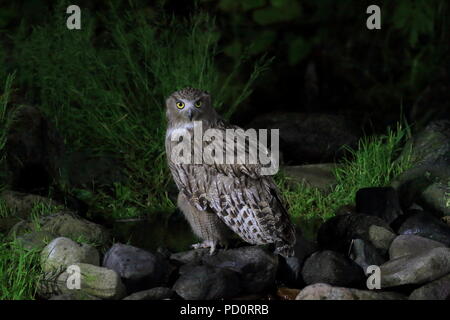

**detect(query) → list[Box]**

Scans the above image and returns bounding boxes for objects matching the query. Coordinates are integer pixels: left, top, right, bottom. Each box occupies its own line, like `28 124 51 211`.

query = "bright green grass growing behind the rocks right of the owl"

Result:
276 124 411 220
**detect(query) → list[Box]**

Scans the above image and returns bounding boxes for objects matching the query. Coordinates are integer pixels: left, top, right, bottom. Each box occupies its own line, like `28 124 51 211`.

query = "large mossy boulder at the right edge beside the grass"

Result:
391 120 450 212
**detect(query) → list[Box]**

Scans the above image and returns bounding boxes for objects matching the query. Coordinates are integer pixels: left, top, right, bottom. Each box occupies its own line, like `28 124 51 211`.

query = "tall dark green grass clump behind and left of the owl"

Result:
8 1 271 218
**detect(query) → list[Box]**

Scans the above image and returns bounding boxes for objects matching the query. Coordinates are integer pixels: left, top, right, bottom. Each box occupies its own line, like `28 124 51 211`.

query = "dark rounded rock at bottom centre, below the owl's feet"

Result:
173 266 240 300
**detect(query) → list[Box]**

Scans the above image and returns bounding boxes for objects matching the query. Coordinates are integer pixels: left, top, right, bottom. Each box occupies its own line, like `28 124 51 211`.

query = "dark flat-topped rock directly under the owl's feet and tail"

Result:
202 246 278 293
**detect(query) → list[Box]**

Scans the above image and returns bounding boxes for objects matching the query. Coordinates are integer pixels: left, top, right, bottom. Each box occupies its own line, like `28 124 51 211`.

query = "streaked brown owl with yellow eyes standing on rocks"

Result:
165 87 295 257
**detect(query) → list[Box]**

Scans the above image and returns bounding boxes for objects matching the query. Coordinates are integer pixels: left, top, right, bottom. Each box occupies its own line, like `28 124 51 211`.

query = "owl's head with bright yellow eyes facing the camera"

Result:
166 87 216 125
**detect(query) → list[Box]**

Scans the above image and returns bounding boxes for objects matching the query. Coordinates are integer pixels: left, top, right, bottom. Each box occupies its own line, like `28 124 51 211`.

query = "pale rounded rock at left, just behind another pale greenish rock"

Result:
41 237 100 272
